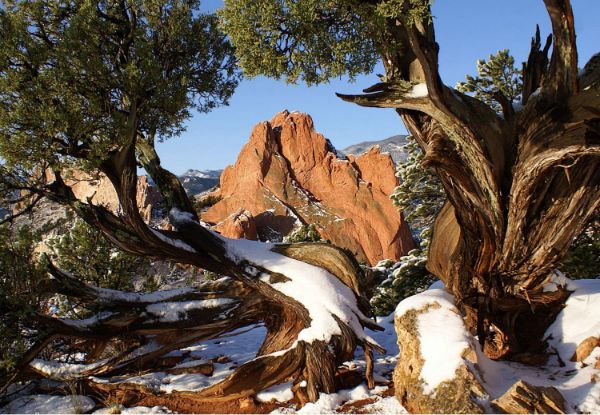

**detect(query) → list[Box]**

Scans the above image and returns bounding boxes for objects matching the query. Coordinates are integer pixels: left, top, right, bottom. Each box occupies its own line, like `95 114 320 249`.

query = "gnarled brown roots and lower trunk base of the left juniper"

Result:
3 240 383 402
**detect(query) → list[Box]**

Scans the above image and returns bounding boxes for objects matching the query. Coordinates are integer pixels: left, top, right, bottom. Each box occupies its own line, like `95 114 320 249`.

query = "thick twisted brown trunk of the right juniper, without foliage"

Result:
339 0 600 362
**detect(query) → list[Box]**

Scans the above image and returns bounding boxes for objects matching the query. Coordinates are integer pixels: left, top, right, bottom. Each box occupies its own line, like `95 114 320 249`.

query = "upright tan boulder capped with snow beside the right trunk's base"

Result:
393 289 487 413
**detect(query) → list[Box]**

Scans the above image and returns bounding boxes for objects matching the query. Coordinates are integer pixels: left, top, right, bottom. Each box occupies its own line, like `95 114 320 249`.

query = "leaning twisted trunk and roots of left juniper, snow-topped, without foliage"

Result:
2 99 383 401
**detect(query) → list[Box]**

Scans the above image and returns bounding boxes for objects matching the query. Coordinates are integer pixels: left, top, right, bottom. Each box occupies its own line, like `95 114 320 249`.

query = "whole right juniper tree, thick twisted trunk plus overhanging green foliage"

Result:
221 0 600 362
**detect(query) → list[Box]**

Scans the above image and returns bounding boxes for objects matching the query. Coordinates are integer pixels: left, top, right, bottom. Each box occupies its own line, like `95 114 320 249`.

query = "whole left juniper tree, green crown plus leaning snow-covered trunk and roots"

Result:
0 0 382 401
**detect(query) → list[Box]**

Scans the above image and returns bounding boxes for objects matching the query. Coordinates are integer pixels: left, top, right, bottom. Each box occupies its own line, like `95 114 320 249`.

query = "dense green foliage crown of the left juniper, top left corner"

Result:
0 0 238 170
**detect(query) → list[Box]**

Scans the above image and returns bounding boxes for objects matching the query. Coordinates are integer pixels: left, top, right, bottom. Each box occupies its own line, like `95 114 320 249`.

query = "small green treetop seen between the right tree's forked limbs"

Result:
456 49 523 113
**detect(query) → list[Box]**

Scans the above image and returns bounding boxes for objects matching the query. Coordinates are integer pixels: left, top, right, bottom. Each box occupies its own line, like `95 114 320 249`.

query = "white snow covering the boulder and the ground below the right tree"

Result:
396 275 600 413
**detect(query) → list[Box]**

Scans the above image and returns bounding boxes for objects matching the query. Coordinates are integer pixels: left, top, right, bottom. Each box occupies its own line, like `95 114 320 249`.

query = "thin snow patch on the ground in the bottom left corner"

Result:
0 395 96 414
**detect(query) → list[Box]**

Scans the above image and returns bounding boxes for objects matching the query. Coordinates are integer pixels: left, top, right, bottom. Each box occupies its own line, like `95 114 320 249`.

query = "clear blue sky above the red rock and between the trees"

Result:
158 0 600 174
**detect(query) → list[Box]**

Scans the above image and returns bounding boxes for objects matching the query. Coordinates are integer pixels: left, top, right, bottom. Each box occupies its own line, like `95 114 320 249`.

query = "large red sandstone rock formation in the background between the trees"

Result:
202 111 415 264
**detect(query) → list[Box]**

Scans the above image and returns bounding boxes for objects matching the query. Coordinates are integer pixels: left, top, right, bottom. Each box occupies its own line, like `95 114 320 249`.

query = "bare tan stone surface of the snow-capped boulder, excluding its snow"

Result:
393 302 486 414
